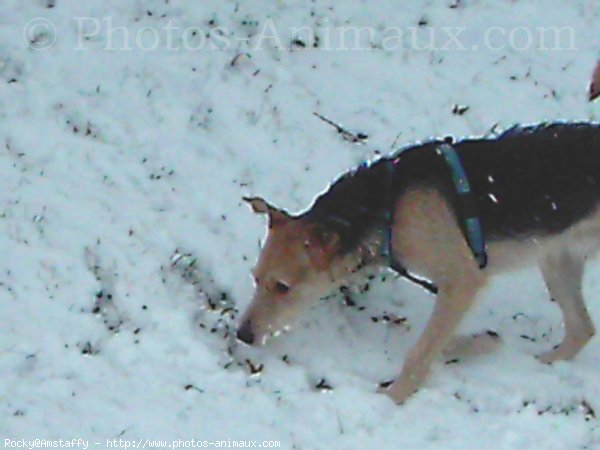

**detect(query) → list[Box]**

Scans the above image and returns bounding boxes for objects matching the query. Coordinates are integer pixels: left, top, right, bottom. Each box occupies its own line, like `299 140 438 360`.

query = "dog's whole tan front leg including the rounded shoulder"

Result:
384 189 486 403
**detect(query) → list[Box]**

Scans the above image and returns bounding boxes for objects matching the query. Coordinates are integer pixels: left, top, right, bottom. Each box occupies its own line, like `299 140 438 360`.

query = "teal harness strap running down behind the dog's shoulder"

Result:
437 143 487 269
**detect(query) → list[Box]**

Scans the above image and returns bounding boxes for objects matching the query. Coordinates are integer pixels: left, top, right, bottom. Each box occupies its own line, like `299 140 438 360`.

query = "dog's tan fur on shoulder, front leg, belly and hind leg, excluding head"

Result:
386 189 600 403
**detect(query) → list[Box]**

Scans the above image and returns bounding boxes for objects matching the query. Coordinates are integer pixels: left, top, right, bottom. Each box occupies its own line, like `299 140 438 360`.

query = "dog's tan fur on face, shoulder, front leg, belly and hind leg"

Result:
241 189 600 403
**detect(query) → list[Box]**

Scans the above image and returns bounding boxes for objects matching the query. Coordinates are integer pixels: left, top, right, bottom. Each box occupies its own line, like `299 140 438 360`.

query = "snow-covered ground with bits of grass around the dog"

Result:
0 0 600 450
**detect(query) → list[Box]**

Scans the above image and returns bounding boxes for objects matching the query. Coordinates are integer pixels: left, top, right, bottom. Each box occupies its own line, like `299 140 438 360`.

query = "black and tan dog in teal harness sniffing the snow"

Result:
237 123 600 404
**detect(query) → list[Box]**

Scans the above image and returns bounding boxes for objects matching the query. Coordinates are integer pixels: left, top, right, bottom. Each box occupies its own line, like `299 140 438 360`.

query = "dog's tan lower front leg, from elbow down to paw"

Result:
381 277 483 404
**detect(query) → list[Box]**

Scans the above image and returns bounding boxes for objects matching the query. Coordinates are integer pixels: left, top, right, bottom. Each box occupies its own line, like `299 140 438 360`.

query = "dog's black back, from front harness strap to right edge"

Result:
396 124 600 240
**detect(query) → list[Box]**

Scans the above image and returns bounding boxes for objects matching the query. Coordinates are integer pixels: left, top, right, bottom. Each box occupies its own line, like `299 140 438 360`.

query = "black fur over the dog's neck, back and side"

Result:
303 123 600 253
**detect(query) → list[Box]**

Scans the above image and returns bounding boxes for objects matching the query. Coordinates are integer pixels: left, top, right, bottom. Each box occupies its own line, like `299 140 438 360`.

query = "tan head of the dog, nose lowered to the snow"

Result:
237 198 339 345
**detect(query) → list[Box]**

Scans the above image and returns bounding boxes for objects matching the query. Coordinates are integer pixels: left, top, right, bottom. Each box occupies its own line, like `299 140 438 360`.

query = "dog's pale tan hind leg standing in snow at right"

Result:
538 246 595 363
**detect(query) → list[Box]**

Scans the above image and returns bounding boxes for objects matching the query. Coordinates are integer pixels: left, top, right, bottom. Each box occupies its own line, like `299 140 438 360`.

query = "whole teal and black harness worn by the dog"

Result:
384 142 487 294
